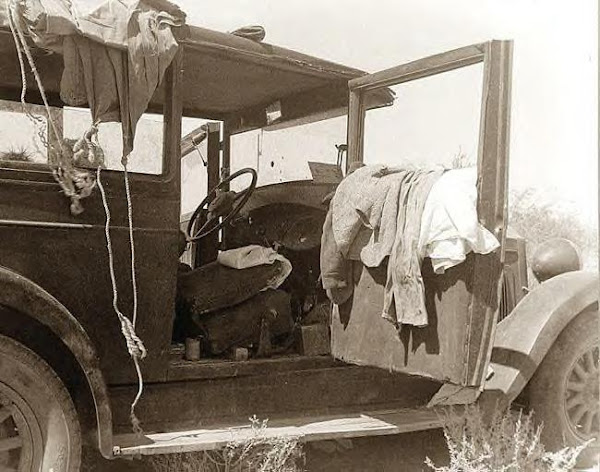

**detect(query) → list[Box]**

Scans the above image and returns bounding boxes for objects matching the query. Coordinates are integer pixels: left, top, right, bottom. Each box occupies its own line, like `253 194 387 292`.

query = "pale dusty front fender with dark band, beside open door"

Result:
479 271 599 404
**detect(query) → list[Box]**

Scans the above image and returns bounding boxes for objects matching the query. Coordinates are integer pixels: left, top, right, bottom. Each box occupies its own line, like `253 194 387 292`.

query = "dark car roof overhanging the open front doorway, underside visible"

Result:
0 25 393 134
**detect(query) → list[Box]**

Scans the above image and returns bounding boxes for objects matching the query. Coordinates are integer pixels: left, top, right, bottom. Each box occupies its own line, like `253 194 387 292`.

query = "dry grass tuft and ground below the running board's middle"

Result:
150 417 305 472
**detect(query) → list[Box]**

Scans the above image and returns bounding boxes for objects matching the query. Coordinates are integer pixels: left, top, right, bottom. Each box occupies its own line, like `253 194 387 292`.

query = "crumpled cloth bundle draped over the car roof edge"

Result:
5 0 185 156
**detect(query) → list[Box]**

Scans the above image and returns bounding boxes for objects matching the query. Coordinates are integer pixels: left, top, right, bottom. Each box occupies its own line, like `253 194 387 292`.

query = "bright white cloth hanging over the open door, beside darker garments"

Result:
419 167 500 274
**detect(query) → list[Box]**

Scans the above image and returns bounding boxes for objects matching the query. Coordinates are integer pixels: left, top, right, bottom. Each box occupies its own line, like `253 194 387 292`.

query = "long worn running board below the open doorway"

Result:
113 409 442 457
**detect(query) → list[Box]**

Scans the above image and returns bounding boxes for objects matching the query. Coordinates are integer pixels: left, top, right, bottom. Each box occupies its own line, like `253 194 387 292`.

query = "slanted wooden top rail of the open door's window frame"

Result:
348 44 485 92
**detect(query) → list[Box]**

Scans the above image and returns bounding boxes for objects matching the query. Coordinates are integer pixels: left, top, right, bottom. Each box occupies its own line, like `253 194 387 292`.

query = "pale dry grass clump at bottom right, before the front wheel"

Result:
425 406 585 472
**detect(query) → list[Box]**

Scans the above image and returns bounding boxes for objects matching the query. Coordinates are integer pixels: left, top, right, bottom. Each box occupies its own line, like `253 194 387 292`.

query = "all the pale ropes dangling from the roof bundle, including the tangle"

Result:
6 0 147 434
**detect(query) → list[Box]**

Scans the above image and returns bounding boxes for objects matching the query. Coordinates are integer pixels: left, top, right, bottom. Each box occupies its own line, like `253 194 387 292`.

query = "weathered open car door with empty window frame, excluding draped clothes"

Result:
332 41 512 390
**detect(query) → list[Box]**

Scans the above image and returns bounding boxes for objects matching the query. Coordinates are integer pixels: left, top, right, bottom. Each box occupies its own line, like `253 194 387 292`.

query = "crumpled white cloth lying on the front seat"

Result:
217 244 292 290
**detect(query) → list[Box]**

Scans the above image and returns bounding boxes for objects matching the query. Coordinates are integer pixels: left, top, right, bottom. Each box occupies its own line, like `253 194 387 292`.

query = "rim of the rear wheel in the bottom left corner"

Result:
0 383 43 472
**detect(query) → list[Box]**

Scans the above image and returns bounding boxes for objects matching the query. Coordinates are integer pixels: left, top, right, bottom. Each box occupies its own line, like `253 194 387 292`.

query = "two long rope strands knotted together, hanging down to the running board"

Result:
96 166 147 434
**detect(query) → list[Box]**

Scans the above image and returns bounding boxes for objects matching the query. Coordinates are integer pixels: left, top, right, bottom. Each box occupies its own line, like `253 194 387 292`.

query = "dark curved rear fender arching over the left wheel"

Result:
0 266 112 458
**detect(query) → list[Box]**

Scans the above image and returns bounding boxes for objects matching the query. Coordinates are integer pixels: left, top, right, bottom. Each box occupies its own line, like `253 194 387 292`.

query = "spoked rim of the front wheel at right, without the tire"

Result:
564 346 600 440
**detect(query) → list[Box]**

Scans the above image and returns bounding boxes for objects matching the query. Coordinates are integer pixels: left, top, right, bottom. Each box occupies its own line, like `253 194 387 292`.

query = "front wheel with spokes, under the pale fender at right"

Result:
527 311 600 467
